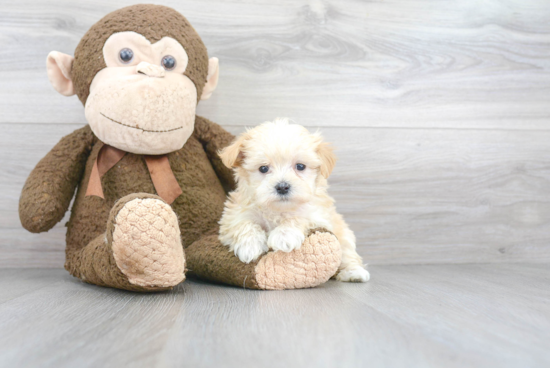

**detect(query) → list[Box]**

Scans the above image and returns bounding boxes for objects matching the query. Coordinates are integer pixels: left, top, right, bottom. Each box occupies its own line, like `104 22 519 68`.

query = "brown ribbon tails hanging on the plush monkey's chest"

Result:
86 144 183 204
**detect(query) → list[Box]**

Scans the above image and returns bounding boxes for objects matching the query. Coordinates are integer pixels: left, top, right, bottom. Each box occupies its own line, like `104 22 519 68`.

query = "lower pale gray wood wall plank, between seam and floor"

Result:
0 124 550 267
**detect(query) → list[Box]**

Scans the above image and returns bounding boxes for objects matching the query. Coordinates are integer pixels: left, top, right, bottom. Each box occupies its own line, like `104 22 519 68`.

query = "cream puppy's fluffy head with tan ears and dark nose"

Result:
220 120 336 210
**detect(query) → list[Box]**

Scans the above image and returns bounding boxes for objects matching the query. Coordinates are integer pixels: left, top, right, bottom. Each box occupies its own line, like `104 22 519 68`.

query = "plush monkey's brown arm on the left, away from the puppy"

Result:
19 125 94 233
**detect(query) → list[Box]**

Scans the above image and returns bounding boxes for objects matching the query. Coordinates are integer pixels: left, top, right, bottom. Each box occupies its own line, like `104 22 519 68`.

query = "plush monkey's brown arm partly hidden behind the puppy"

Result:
195 115 235 193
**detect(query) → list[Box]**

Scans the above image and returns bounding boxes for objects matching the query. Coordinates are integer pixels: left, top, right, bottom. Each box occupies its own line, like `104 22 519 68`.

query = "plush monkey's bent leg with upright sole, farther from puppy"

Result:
65 193 185 291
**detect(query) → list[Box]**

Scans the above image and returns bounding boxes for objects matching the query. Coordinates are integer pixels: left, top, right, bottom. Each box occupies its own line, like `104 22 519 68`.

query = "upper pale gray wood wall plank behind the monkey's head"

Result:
0 0 550 130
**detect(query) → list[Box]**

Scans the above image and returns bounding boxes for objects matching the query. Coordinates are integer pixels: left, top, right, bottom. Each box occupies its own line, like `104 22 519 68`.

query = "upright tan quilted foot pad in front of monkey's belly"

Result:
112 198 185 287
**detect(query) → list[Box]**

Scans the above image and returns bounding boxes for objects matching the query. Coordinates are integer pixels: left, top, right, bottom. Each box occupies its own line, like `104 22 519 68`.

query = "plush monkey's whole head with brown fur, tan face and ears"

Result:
47 5 219 155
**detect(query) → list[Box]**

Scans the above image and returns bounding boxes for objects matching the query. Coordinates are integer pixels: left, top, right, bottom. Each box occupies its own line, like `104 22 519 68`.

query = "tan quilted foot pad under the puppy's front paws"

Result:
256 232 342 290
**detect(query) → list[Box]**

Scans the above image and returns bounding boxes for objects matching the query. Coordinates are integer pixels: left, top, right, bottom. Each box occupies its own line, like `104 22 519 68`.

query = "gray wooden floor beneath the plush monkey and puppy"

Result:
0 264 550 368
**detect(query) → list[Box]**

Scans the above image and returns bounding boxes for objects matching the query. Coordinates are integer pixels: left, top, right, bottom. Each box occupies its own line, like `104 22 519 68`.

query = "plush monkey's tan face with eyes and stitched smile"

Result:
85 32 197 155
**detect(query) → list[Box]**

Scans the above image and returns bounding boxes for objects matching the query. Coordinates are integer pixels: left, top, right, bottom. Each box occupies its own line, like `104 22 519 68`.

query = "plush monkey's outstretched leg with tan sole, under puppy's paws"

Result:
185 229 342 290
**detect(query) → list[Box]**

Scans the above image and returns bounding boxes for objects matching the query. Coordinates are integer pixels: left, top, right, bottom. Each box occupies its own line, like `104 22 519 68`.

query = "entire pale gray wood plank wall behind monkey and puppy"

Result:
0 0 550 267
